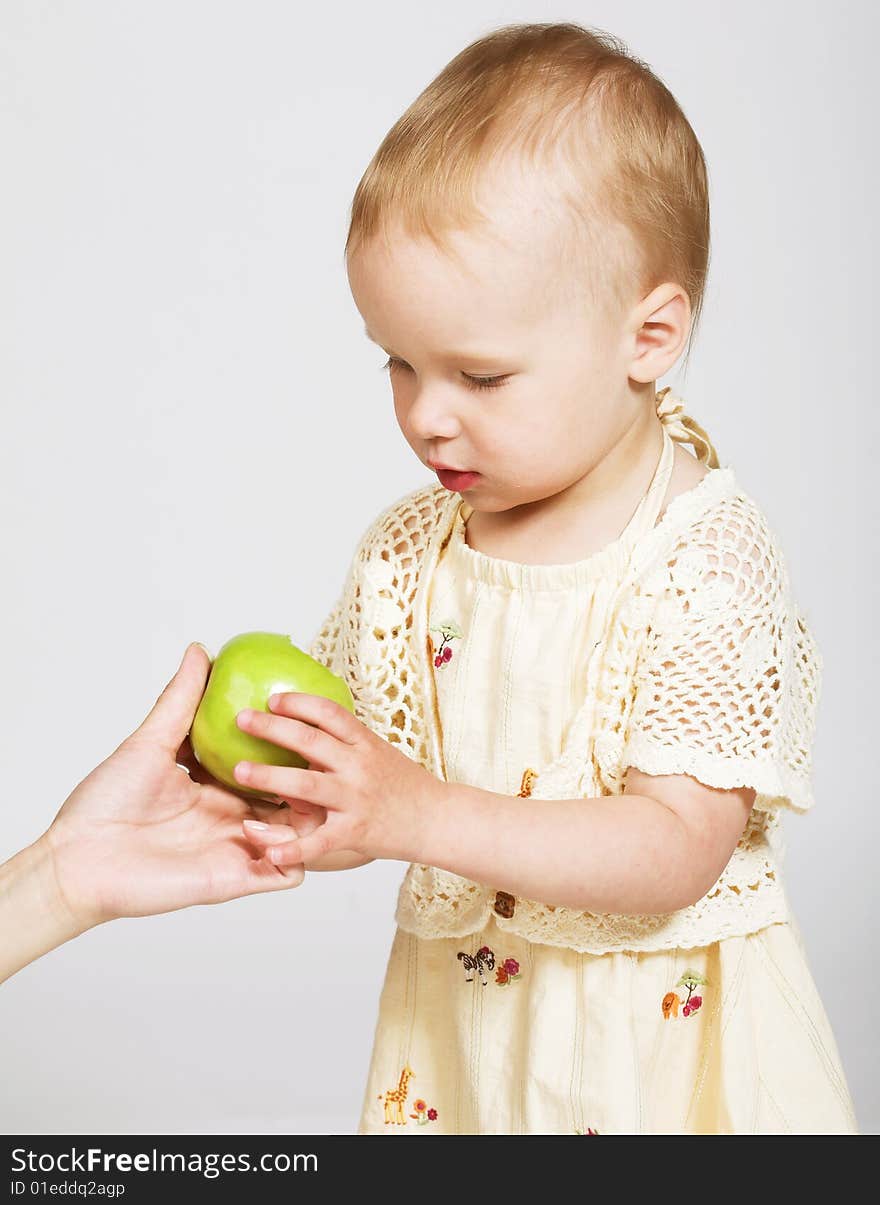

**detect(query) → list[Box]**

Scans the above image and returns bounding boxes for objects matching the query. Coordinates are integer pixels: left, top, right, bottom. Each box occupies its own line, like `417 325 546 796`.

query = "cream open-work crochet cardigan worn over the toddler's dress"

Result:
309 400 822 953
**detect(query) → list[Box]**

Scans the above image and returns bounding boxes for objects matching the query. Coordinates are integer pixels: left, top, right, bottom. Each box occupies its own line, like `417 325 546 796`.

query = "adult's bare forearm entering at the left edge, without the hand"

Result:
0 841 84 983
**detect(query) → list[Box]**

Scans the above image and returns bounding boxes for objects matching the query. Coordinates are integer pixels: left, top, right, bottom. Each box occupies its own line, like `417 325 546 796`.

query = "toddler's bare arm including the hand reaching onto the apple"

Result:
236 692 755 915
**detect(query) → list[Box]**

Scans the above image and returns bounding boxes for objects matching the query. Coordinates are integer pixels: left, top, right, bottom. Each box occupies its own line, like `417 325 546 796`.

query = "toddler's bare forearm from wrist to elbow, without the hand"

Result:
400 783 711 913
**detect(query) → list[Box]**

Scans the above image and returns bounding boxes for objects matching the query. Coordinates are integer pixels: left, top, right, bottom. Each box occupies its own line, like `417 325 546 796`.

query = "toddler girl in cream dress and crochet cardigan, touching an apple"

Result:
232 24 857 1135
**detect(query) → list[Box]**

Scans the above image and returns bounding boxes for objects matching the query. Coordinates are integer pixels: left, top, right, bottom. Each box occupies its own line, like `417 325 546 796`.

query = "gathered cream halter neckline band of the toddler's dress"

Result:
446 427 679 590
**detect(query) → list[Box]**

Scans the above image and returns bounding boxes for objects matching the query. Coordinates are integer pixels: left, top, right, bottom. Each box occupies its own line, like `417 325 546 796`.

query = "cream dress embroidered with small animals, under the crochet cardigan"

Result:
358 428 858 1135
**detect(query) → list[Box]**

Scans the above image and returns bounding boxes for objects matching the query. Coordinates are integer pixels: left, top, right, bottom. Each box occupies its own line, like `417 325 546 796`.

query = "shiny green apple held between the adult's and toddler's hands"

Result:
189 631 354 799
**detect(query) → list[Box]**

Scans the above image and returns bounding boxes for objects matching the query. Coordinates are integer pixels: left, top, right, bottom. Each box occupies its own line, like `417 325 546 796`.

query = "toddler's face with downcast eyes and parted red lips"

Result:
348 183 645 511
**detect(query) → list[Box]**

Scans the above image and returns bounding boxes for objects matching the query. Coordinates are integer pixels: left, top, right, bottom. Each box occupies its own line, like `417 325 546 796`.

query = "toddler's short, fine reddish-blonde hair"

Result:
345 22 718 468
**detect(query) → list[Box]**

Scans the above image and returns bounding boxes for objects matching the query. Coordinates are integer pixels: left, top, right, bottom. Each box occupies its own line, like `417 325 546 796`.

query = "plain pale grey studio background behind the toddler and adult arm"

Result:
0 0 880 1134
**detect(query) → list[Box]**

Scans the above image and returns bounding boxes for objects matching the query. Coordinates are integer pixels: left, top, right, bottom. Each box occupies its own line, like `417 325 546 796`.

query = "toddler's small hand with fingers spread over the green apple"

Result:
234 692 444 865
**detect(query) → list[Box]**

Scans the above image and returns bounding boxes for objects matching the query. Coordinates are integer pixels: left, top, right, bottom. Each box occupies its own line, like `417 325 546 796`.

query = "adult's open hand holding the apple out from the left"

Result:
37 645 316 929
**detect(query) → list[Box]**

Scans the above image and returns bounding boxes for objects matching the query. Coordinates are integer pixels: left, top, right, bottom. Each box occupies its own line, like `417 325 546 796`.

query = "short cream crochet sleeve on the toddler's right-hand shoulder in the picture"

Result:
623 495 822 812
